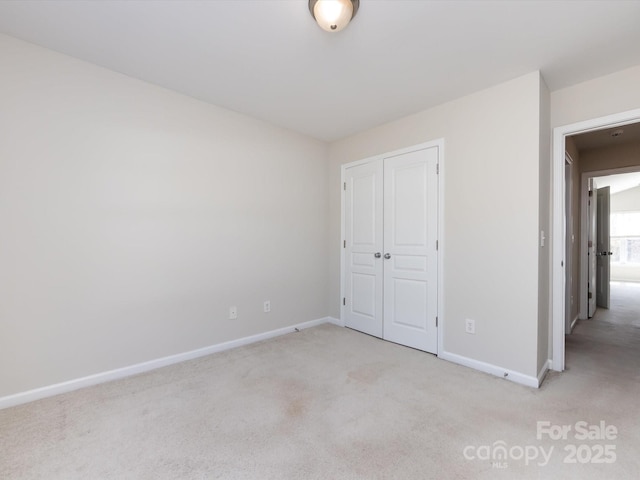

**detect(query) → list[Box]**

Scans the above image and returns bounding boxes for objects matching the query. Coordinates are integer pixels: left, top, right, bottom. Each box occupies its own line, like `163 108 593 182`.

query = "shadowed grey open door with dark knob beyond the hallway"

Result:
596 187 611 308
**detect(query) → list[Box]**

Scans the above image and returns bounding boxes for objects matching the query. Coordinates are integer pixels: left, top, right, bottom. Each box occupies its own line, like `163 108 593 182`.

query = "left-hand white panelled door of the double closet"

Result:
343 160 383 337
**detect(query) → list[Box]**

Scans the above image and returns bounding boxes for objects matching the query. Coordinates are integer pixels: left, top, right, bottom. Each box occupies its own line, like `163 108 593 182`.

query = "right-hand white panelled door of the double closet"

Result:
383 147 438 353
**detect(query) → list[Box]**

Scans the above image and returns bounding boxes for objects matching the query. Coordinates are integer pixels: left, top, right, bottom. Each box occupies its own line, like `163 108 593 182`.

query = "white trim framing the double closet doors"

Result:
339 138 445 356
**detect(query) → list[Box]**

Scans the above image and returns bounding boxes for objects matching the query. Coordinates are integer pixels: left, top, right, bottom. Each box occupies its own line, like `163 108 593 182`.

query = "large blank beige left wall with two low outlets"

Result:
0 32 329 397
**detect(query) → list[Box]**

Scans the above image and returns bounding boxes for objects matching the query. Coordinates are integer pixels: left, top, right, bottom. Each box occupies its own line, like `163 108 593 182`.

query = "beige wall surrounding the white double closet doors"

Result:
330 72 546 375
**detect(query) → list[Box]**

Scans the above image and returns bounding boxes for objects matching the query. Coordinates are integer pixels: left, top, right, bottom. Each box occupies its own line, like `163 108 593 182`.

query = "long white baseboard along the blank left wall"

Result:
0 317 340 410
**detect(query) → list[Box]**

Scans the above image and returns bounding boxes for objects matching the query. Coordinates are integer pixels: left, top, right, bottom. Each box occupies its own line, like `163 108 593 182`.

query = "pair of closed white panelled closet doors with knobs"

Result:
342 146 439 353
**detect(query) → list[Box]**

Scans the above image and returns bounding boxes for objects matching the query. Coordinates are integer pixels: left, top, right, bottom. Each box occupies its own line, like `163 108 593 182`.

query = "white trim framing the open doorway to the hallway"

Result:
550 109 640 372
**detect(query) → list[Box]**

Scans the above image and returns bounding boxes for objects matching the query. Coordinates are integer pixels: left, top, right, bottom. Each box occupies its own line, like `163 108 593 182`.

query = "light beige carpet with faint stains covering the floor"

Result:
0 286 640 480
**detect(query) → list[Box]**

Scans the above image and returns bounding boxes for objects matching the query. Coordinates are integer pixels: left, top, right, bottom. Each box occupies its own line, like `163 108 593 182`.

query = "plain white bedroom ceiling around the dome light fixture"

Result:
0 0 640 141
